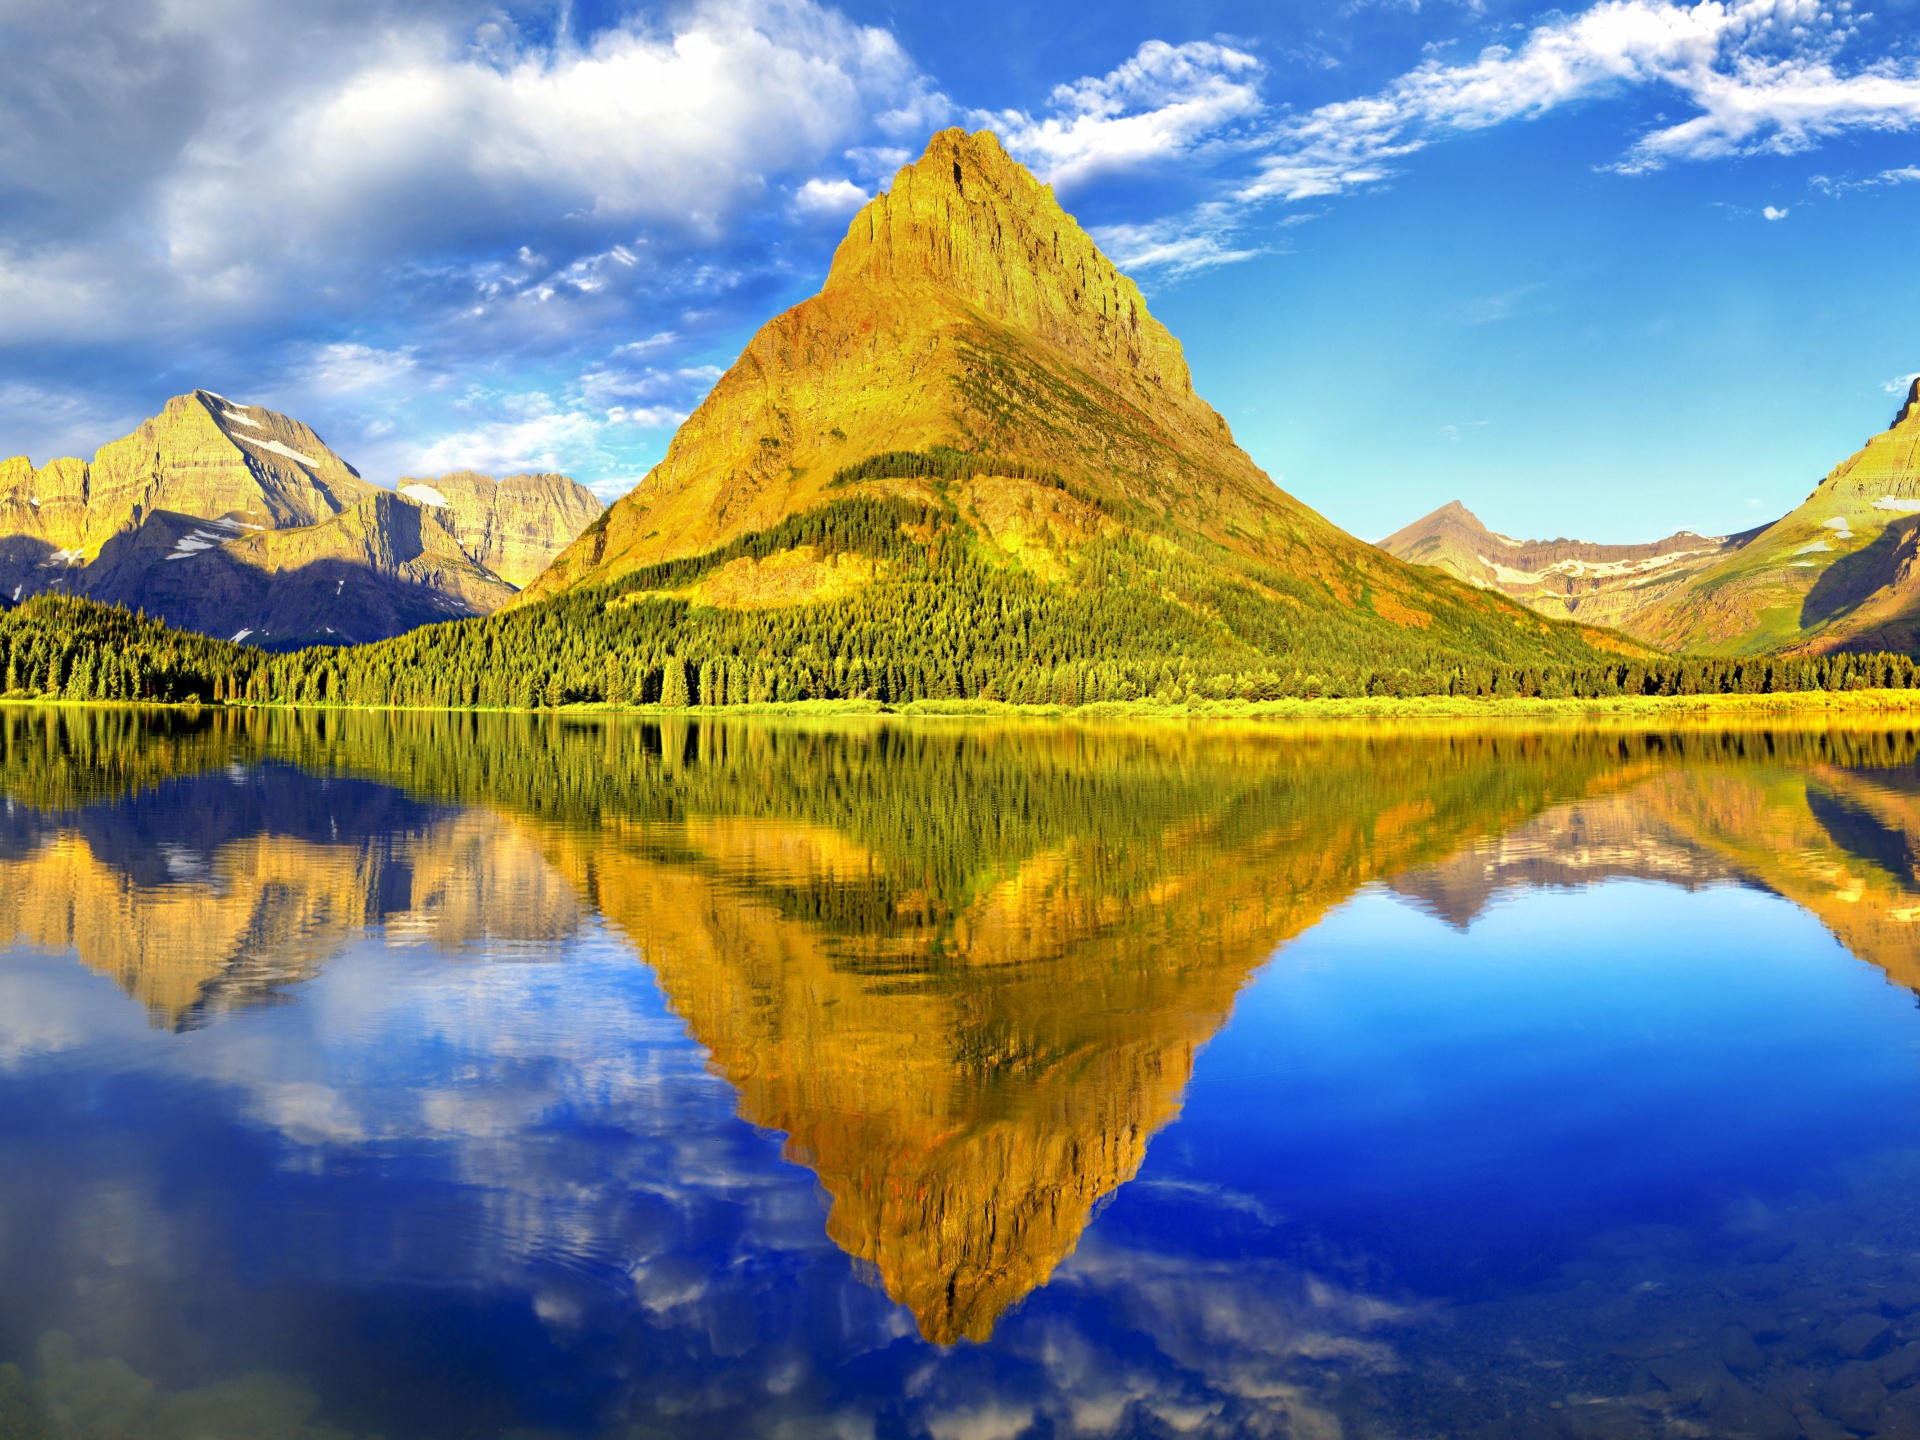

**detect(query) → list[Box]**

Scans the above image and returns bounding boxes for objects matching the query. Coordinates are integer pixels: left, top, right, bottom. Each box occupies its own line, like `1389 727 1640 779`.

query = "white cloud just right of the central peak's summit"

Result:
973 40 1265 186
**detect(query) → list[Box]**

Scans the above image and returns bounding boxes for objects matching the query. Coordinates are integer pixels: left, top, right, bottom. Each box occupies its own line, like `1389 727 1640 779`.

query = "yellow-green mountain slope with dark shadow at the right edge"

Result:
1630 380 1920 655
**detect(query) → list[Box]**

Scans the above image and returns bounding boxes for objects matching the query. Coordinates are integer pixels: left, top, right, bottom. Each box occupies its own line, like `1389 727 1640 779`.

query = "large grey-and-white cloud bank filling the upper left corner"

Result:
0 0 945 344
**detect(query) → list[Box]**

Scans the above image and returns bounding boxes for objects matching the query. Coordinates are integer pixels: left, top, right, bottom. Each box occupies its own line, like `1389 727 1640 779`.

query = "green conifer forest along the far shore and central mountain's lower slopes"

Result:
0 497 1914 710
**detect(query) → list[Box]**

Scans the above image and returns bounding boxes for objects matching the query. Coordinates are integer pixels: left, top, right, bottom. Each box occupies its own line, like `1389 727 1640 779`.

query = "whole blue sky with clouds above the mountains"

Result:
0 0 1920 541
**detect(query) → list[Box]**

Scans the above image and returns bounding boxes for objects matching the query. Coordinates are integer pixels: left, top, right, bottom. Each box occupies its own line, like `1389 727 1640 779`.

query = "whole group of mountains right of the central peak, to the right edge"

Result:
1380 380 1920 655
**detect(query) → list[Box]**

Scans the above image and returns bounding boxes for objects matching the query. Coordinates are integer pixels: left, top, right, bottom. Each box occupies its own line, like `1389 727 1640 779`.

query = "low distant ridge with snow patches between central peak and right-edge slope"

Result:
1380 499 1759 628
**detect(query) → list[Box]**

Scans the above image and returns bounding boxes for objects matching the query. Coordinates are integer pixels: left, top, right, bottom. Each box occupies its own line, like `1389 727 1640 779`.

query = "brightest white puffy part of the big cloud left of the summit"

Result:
167 0 914 275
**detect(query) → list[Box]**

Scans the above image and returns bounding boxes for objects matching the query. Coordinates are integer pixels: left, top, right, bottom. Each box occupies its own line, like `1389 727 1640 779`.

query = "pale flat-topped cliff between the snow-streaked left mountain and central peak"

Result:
396 470 605 589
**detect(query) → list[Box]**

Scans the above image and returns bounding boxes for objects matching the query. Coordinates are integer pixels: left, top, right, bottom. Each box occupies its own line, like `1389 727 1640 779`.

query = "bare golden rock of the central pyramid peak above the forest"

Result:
515 131 1620 668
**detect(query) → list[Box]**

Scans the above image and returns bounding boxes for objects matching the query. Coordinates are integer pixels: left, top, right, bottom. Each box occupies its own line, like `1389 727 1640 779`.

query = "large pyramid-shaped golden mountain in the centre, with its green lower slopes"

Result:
513 131 1620 693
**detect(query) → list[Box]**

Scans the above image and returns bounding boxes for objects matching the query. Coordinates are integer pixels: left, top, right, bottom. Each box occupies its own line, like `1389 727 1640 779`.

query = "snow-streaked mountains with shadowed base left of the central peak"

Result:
0 390 601 649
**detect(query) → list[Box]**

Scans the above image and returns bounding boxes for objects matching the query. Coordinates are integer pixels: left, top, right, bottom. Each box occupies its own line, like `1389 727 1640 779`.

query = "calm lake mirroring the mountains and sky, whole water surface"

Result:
0 710 1920 1440
